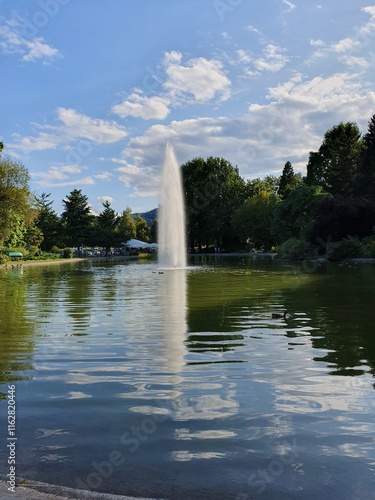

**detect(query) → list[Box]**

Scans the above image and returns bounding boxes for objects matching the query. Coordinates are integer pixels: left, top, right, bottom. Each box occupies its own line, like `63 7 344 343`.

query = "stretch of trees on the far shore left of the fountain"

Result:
0 144 156 257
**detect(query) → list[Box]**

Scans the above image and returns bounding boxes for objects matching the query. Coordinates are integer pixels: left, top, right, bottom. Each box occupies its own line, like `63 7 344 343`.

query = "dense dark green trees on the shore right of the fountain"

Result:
182 115 375 258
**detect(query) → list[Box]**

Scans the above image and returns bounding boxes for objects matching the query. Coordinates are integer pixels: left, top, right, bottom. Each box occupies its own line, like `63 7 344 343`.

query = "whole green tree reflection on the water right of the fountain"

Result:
187 259 375 375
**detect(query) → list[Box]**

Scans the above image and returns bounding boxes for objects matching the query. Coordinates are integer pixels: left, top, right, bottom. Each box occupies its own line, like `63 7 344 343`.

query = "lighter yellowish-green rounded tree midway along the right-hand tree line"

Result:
232 191 279 248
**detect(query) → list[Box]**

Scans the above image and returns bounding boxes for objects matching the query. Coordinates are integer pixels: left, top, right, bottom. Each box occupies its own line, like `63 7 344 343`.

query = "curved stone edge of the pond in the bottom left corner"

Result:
0 481 163 500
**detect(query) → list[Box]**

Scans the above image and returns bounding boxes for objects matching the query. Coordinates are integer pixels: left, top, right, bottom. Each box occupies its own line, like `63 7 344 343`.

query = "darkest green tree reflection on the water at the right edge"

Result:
286 263 375 375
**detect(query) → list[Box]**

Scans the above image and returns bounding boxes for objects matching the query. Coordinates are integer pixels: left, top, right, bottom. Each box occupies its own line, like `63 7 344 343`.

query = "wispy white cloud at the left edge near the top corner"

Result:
0 21 61 63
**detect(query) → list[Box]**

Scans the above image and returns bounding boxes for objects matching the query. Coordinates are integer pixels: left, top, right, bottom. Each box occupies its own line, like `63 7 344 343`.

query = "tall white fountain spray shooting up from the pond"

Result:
158 144 186 268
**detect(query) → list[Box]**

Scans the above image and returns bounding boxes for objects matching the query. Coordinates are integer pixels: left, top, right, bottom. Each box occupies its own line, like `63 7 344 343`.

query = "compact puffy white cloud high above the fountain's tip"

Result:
163 51 231 102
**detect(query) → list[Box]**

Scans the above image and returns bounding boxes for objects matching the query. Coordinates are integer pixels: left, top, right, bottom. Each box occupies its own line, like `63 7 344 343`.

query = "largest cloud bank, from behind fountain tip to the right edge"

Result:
124 73 375 187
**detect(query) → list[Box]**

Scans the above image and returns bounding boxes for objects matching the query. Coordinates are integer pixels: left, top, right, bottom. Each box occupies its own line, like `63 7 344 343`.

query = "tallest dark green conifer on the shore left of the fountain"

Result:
61 189 93 254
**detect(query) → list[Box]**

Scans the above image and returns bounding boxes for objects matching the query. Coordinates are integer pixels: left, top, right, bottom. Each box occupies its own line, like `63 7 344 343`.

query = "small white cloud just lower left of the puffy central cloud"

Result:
111 93 169 120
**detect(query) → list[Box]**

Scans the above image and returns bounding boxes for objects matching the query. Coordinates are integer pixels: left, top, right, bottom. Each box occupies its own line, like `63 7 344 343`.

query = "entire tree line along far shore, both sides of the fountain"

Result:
0 114 375 258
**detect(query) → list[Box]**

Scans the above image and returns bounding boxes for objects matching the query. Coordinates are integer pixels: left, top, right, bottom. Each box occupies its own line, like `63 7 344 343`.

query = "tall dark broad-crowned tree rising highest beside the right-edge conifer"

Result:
306 122 363 196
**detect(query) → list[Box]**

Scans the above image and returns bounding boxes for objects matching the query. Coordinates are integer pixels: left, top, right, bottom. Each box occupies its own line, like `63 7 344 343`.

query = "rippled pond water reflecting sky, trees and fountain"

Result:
0 257 375 500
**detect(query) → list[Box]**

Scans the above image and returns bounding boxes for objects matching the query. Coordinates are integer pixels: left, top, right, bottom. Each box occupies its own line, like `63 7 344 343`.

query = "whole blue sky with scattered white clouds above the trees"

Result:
0 0 375 213
